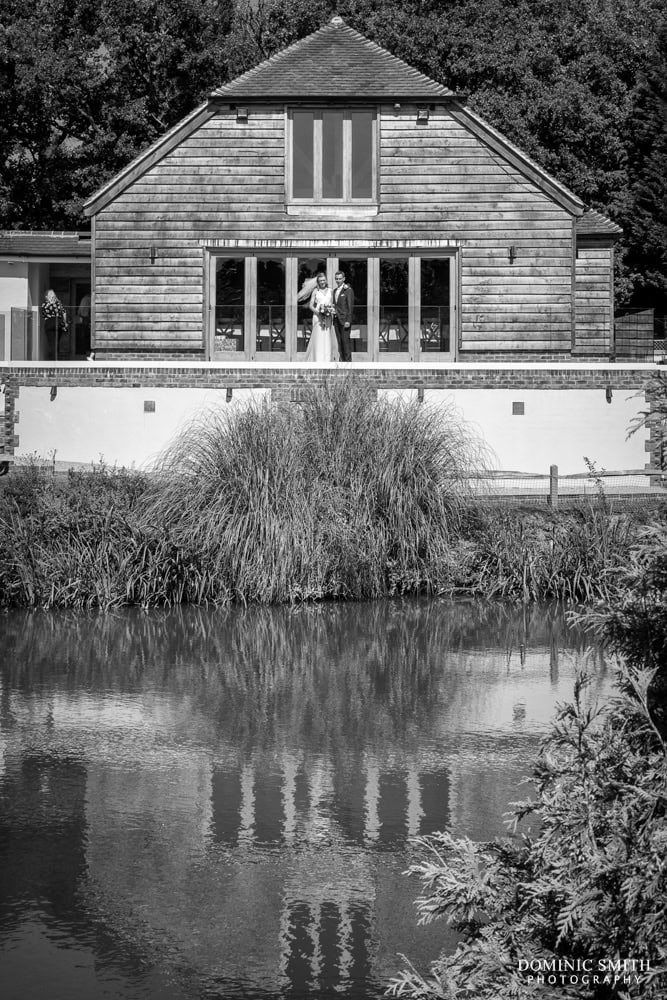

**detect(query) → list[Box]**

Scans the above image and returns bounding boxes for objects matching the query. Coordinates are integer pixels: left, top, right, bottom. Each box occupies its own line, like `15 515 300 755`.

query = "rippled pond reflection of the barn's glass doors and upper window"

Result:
211 753 456 992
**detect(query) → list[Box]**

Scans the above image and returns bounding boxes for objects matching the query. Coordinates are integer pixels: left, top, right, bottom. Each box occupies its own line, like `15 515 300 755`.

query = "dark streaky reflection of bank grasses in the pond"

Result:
1 600 596 757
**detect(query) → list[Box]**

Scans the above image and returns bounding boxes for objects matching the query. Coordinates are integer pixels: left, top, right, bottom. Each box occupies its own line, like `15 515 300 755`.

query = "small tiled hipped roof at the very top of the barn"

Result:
211 17 455 100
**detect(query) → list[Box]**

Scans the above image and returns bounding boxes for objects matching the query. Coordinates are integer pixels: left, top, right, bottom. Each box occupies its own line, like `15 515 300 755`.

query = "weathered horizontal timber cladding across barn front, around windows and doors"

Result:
95 105 573 351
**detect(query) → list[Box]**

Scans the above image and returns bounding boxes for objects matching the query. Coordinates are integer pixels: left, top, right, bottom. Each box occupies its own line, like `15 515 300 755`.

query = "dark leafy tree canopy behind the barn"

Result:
0 0 667 309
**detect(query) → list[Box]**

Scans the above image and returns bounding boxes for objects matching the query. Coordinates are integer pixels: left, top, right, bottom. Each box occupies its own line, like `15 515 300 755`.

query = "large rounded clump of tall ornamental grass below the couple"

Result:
145 377 480 603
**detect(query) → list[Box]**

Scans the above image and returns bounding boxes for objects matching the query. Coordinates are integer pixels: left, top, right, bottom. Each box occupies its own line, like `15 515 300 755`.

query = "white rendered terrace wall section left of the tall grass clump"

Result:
14 385 269 468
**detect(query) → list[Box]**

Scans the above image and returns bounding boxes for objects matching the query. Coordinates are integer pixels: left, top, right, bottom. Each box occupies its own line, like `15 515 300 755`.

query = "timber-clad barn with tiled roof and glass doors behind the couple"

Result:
86 17 620 364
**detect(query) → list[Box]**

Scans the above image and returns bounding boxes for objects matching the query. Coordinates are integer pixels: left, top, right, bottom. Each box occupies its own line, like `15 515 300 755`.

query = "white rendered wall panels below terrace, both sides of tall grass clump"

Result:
15 383 647 475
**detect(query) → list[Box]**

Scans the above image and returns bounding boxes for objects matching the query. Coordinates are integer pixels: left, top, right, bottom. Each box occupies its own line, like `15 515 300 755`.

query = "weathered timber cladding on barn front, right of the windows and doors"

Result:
382 114 572 351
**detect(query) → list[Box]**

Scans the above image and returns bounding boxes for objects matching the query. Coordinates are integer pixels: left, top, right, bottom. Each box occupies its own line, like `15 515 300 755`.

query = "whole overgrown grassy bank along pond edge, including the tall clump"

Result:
0 379 656 608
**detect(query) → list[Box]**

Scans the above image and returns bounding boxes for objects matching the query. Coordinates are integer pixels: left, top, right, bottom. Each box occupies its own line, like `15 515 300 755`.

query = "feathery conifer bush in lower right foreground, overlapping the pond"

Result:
388 667 667 1000
